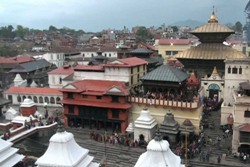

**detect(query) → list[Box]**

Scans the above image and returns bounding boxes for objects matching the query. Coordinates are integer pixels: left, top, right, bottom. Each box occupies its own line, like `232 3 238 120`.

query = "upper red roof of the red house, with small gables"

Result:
61 80 129 96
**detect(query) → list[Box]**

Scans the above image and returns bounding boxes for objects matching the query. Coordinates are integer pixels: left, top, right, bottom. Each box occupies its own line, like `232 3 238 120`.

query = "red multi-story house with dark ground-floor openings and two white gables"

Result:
61 80 131 133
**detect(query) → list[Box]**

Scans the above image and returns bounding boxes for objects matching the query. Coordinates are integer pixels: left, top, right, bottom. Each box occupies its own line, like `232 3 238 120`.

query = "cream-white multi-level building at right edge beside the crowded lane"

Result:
221 58 250 153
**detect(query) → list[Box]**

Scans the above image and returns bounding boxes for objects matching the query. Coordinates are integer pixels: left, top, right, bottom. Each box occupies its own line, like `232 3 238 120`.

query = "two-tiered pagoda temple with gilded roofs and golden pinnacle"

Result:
176 8 246 78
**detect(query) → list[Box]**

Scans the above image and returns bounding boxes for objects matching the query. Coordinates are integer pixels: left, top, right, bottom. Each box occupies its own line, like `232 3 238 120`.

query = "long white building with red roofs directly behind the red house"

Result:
48 57 147 88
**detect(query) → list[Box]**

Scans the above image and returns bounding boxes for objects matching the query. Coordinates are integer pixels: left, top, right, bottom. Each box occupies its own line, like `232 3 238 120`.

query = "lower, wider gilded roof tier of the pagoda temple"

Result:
175 43 247 60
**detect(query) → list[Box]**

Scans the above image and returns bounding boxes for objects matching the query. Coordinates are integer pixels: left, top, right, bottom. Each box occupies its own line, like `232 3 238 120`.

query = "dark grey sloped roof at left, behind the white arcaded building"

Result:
10 59 50 73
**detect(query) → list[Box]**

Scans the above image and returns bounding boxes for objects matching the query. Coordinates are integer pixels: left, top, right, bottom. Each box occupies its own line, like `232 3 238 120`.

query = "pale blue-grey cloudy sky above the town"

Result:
0 0 249 32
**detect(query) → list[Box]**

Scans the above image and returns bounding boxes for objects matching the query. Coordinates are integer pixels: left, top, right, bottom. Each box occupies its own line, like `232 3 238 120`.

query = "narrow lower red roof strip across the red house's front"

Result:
61 99 131 109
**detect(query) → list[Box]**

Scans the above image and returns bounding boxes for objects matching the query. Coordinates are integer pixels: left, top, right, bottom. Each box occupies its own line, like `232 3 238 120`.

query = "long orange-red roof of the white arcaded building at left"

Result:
5 87 62 96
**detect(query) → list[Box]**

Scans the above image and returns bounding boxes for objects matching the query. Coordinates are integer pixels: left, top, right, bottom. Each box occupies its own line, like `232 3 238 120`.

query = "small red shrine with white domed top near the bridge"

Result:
20 98 36 117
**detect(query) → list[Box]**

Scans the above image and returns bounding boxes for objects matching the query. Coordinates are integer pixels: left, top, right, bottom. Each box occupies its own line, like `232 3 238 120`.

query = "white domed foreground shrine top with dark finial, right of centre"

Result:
135 132 184 167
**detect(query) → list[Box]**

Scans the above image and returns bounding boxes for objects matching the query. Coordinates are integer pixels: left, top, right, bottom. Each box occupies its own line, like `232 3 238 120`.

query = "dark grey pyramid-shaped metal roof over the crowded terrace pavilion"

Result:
141 65 188 82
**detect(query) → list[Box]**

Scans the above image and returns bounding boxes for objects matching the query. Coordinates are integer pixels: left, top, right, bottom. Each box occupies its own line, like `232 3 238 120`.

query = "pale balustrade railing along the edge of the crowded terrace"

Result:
128 96 200 109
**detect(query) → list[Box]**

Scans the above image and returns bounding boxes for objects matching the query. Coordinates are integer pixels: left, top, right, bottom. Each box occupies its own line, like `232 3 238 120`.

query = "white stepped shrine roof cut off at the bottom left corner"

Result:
0 139 24 167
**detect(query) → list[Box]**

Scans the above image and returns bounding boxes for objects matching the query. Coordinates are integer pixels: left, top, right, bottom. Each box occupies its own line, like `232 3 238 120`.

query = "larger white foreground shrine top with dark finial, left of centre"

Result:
35 121 99 167
